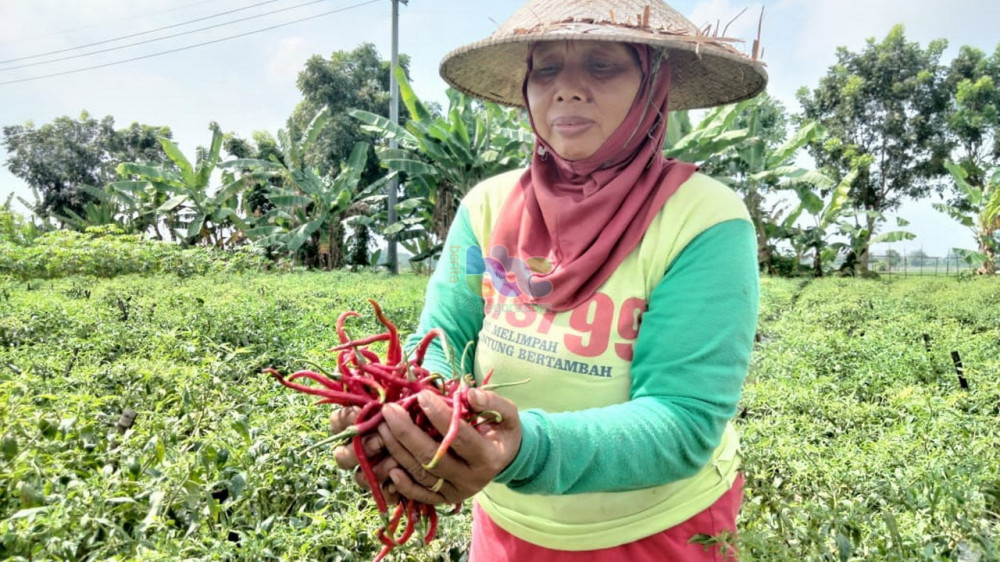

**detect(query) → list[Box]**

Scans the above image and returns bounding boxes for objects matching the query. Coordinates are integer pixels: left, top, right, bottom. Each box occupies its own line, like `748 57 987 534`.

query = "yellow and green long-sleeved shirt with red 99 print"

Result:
406 167 758 550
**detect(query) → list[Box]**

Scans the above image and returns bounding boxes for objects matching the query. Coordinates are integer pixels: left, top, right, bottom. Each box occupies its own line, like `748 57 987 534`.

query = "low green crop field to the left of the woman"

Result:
0 273 468 561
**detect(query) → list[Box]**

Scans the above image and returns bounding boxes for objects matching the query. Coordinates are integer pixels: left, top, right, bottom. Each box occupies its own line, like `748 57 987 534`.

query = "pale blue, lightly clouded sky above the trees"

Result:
0 0 1000 256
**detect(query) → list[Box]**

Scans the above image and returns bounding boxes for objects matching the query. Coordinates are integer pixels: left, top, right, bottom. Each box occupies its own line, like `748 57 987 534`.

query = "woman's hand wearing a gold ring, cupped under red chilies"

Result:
378 389 521 504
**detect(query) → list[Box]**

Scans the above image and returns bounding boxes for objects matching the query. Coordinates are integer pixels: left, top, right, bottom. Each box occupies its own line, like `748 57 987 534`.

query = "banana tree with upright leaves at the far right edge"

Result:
934 162 1000 275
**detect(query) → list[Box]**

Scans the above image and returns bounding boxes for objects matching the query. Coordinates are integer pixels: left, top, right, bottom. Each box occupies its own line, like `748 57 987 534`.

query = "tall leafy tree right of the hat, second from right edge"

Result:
798 25 950 274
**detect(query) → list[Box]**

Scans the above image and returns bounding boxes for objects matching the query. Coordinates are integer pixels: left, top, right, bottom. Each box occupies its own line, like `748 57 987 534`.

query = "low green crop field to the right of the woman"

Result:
739 278 1000 561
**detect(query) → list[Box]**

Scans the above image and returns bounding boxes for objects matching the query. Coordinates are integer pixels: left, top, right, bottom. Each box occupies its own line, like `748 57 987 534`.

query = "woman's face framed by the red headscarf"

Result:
527 41 642 160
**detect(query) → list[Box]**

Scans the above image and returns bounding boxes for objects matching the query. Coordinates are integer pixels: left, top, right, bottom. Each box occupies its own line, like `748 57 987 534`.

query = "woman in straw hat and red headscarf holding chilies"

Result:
333 0 766 562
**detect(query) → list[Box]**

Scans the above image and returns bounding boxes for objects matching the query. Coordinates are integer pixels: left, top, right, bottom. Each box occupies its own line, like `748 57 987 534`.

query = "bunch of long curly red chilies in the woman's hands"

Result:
264 300 499 562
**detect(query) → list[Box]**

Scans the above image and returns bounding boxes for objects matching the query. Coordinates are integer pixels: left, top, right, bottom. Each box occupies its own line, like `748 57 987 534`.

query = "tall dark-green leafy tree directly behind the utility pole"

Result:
287 43 409 185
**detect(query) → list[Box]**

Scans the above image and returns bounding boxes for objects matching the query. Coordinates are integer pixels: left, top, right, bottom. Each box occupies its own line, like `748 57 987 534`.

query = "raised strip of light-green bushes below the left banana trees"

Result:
0 227 269 280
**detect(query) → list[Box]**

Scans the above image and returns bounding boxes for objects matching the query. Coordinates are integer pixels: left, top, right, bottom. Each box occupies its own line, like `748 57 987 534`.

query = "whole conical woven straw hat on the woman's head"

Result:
441 0 767 110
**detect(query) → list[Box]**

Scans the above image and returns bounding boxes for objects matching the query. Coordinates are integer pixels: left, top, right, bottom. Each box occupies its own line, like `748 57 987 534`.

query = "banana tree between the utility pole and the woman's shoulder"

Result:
349 68 534 261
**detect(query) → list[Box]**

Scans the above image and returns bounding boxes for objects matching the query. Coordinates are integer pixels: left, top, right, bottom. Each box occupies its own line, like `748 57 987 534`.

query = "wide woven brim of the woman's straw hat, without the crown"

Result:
440 24 767 111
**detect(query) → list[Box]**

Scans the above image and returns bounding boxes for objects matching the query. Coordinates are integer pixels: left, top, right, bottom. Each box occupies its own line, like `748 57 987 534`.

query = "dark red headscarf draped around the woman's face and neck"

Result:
489 45 697 310
